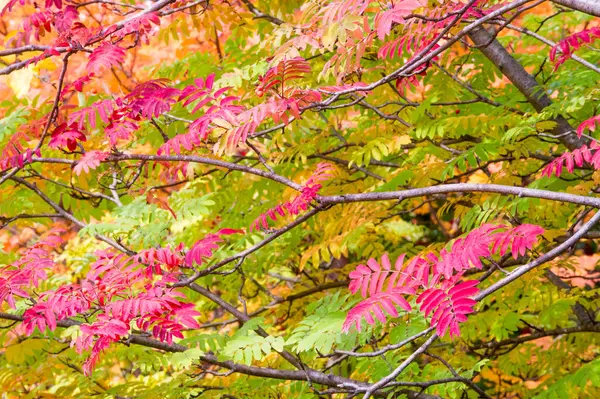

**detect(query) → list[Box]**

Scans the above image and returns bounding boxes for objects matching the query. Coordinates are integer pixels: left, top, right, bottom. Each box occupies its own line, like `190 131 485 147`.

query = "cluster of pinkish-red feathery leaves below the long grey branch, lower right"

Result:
343 223 548 337
